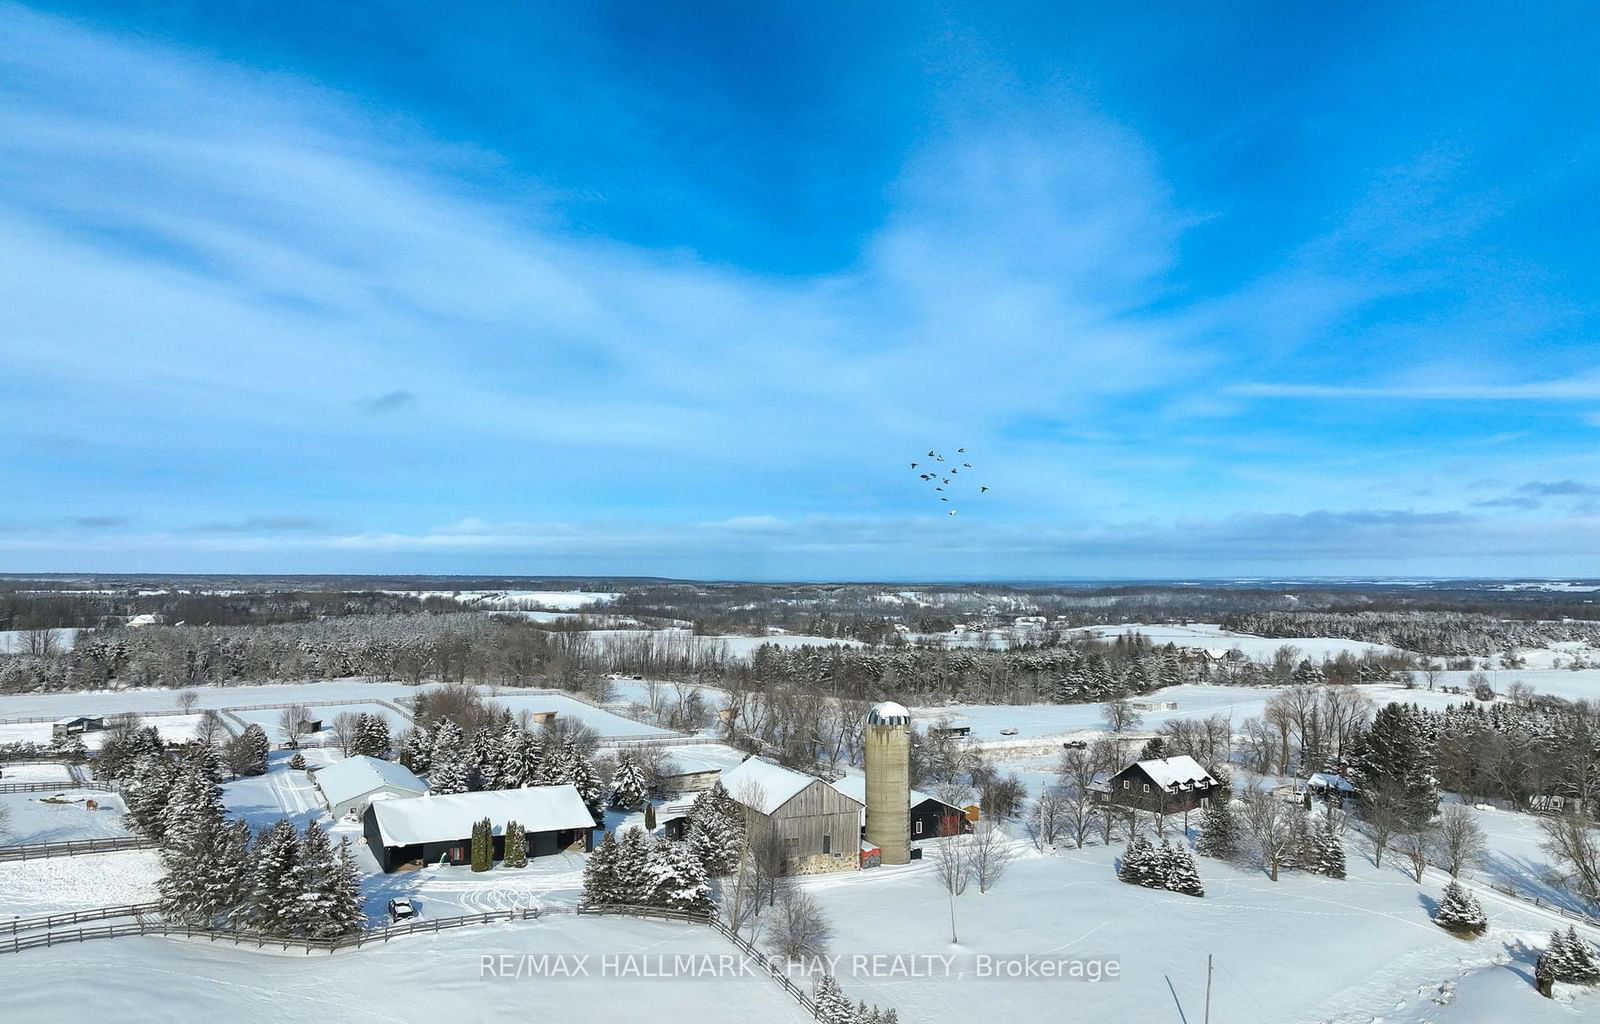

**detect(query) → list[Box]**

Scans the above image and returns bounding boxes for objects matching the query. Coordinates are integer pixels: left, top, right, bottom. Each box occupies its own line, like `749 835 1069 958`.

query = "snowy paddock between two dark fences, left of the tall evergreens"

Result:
0 850 162 921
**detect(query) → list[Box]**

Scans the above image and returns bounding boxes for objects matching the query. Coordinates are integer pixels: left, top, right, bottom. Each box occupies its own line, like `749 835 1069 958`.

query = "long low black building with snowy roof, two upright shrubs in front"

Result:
362 784 595 872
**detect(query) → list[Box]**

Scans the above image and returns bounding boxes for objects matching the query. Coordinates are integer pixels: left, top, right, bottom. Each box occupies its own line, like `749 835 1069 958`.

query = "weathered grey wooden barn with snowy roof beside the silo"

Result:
722 757 866 875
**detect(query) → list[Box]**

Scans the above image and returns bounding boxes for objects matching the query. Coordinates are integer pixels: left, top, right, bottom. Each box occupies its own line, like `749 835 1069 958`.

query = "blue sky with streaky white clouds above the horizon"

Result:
0 3 1600 579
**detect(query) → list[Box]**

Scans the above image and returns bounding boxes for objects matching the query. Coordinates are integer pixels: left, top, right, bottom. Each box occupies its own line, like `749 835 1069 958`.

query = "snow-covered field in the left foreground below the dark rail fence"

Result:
3 917 812 1024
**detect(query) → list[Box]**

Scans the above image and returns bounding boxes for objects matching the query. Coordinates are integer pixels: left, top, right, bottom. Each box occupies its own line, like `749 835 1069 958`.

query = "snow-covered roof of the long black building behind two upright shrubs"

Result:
368 784 595 846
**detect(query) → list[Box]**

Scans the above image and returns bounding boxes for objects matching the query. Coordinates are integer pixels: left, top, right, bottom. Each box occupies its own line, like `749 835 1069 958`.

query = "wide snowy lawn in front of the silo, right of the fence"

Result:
805 846 1600 1024
